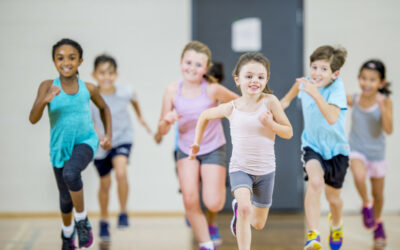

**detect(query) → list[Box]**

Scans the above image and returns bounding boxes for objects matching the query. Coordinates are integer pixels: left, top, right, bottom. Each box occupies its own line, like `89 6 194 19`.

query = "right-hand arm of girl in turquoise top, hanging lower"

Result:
86 83 112 150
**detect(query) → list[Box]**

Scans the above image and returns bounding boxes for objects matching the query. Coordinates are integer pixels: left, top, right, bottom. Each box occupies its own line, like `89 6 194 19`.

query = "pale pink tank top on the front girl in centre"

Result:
229 100 275 175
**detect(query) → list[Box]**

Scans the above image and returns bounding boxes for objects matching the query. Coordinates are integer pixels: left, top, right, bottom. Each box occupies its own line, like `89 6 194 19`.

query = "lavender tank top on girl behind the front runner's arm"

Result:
174 79 226 155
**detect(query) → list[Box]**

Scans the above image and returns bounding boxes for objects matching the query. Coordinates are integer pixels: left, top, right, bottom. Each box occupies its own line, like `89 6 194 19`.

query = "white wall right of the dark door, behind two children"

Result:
304 0 400 211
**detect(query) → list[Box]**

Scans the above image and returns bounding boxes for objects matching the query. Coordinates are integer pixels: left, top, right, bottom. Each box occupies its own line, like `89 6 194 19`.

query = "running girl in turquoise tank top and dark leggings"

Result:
29 39 112 250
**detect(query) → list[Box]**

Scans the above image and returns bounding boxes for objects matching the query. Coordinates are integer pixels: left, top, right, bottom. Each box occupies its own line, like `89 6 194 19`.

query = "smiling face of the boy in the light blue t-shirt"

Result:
310 60 339 88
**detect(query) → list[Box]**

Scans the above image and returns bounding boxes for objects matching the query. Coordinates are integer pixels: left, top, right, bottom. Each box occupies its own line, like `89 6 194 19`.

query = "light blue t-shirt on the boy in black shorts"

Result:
298 78 349 160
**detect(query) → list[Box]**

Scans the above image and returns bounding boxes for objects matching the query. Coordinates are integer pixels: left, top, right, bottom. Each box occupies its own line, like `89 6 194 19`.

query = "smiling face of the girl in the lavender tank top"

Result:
181 50 208 82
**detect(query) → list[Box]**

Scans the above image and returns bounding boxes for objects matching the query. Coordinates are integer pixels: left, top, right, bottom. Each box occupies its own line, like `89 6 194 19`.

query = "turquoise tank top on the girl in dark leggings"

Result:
47 78 99 168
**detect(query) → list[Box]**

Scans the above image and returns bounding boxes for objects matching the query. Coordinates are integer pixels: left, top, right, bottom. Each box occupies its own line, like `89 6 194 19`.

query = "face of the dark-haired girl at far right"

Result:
358 69 385 96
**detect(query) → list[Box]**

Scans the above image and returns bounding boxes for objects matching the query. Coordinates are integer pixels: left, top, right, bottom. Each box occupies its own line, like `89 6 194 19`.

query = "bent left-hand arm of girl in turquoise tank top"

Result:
29 80 57 124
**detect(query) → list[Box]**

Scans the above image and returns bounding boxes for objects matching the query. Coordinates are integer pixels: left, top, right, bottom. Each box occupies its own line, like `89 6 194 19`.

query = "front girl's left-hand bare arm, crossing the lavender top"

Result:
189 103 233 159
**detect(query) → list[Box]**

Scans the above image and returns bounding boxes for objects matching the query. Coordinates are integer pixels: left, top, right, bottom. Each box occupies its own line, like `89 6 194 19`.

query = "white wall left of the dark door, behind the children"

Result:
0 0 191 212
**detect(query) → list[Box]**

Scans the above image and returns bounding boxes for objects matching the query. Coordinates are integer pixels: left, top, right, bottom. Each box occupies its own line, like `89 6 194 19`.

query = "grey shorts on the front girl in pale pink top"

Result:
229 171 275 208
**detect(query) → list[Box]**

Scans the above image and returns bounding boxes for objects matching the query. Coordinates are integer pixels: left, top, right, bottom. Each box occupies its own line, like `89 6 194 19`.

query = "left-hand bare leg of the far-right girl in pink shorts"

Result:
350 158 369 206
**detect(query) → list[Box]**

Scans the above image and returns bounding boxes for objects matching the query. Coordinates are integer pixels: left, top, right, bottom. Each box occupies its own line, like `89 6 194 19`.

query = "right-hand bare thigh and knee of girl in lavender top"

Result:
200 164 226 213
